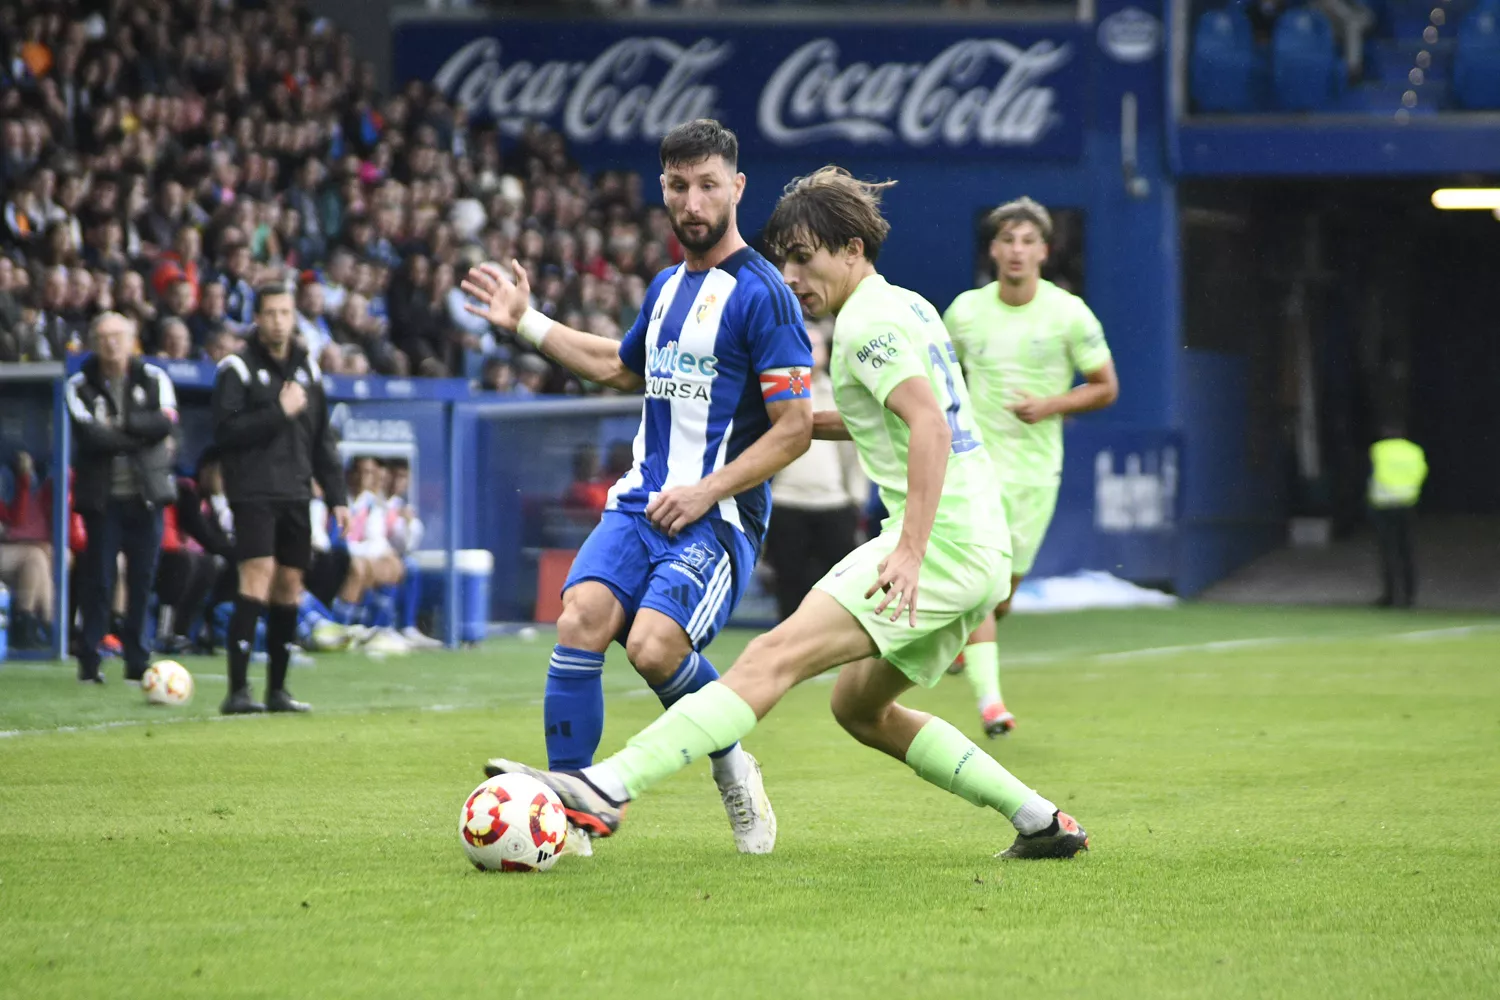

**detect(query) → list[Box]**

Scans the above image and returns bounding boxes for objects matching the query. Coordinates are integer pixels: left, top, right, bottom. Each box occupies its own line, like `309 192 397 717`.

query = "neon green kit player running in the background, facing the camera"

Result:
944 198 1121 739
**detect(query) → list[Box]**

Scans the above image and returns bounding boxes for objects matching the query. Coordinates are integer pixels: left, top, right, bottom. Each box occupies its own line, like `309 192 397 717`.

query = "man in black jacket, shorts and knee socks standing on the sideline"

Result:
213 285 350 715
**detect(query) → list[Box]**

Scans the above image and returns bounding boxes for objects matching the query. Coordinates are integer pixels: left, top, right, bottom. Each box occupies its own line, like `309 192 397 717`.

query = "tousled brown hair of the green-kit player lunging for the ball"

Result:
762 165 896 264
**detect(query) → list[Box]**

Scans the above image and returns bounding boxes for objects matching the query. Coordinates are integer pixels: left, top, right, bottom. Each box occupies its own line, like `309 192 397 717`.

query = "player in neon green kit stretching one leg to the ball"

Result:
486 166 1089 858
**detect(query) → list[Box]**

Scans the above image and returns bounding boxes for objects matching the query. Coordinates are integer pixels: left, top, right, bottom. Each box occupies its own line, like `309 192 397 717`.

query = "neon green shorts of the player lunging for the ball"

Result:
818 525 1011 688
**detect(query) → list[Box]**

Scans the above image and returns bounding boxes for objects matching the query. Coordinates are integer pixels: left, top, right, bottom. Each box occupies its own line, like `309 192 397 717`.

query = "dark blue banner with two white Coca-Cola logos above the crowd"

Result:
395 21 1091 159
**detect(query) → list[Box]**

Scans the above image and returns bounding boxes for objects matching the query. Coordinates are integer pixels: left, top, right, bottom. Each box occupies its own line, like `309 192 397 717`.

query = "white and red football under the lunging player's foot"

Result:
459 774 567 871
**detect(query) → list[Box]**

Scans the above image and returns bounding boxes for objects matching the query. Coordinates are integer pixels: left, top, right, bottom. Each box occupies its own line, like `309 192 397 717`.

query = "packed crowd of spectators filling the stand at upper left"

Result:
0 0 683 394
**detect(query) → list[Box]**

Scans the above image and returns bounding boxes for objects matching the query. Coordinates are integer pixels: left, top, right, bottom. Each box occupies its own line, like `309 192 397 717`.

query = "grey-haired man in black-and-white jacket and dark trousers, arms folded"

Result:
65 312 177 684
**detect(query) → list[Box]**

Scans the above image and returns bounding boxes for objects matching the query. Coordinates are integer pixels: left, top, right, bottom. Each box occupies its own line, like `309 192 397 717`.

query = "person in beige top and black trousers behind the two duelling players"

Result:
765 322 870 619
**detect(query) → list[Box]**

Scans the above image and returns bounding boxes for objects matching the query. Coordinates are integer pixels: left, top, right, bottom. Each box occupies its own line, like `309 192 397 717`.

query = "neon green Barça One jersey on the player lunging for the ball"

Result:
830 274 1010 552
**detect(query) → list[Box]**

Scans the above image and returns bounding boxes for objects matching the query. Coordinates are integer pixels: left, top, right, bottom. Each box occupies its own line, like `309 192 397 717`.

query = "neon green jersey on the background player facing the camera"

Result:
944 280 1110 486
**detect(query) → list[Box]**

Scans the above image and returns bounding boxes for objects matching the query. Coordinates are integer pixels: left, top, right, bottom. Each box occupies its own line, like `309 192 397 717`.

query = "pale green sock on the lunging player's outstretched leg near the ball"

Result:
605 681 756 799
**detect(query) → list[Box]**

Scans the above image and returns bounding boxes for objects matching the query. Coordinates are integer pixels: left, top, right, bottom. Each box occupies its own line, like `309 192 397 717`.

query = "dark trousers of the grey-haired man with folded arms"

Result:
77 498 162 678
